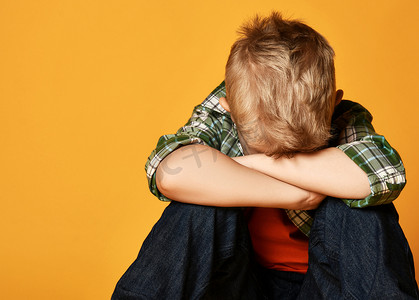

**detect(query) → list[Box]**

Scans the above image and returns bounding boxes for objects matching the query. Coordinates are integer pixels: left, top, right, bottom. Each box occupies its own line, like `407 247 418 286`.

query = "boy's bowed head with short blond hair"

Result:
222 13 336 157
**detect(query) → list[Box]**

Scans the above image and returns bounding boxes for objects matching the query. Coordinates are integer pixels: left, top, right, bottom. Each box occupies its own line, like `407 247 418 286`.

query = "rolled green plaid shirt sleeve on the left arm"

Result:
145 82 230 201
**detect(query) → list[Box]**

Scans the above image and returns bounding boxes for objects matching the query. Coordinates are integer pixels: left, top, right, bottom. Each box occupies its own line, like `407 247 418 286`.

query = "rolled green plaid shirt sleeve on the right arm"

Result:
334 101 406 207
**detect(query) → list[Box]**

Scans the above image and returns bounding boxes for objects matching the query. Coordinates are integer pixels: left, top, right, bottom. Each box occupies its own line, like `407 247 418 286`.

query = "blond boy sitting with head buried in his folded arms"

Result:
113 13 418 299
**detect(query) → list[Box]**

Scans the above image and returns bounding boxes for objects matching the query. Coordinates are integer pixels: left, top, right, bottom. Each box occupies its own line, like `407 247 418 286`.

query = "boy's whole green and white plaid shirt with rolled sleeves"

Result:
145 82 406 236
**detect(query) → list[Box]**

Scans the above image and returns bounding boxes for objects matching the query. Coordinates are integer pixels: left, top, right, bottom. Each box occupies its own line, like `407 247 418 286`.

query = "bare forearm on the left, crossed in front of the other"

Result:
156 145 320 209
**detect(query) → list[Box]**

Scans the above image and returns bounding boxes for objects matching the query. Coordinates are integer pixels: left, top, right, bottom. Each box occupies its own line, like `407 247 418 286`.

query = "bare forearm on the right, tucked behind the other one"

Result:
236 148 371 199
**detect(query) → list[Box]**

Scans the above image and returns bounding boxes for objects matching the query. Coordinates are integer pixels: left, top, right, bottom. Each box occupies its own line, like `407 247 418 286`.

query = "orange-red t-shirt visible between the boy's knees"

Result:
248 208 308 274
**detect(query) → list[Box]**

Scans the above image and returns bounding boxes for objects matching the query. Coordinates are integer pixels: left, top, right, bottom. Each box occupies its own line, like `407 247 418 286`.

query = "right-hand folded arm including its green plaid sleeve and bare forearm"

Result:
235 100 406 207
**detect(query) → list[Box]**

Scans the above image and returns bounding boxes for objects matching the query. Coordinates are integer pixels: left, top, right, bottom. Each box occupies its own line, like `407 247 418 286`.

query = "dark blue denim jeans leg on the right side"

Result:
298 198 419 300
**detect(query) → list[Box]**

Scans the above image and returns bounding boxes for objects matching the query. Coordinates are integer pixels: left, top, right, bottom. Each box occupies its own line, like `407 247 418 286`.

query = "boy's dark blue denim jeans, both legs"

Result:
112 198 419 300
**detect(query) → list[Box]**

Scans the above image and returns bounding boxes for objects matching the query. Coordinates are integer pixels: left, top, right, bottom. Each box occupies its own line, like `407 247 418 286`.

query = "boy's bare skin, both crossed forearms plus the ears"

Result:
156 90 371 210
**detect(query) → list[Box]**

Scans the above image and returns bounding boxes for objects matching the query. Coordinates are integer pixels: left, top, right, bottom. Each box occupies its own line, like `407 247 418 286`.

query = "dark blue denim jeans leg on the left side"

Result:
112 201 258 300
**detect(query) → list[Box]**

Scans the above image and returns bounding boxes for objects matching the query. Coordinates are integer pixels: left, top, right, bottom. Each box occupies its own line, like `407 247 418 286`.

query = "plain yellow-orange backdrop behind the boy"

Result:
0 0 419 300
